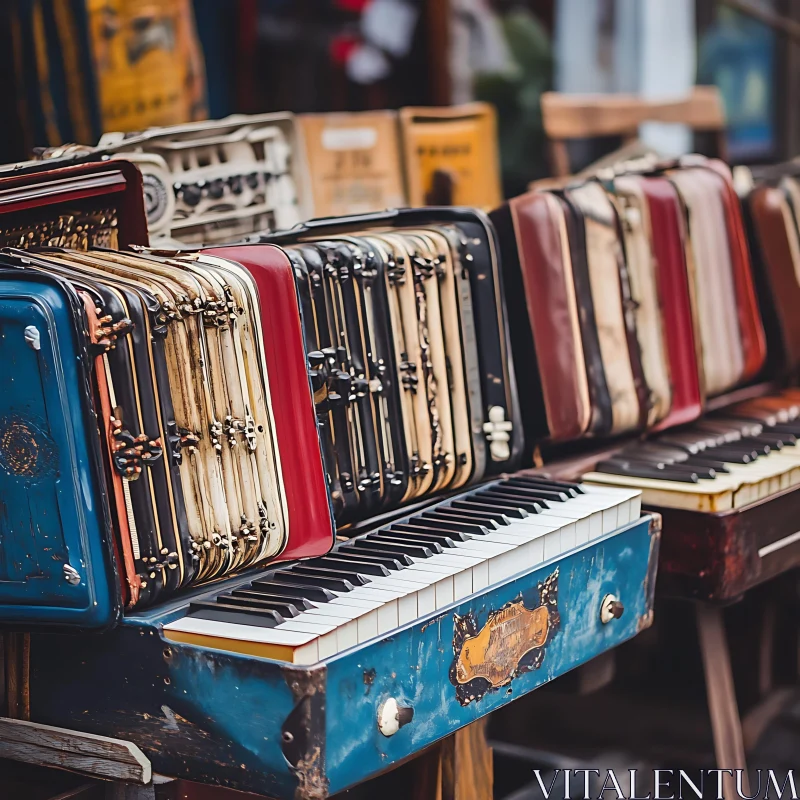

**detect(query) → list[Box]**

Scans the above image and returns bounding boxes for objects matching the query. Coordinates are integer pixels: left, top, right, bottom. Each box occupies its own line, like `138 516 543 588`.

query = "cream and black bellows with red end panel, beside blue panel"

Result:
0 245 332 605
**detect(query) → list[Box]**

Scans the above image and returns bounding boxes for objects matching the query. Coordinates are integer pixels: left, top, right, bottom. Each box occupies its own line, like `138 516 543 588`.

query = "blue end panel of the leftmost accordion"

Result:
0 276 118 628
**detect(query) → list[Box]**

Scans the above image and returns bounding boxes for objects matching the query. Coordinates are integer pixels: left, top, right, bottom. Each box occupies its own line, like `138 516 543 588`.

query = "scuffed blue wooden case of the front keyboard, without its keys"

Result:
31 517 658 798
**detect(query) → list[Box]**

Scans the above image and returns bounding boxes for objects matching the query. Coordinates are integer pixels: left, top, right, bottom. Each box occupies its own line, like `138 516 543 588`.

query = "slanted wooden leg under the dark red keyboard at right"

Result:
697 603 750 798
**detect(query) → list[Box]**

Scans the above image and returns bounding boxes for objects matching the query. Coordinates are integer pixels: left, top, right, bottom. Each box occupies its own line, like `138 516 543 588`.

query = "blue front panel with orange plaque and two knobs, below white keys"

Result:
325 518 657 792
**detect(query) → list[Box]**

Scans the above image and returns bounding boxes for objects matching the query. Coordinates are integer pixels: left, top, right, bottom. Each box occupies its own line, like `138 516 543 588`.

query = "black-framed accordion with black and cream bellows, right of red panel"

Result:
266 208 523 523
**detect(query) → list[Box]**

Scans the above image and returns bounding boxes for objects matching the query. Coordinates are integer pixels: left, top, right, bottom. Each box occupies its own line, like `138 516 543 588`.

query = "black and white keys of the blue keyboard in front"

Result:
165 476 640 664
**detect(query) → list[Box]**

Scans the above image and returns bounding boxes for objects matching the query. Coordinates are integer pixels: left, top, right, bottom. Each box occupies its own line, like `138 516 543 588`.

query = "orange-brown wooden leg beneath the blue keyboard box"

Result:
414 717 494 800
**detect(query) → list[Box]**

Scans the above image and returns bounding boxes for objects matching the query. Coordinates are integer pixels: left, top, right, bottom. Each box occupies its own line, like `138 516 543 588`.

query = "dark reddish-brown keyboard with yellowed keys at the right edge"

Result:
583 389 800 601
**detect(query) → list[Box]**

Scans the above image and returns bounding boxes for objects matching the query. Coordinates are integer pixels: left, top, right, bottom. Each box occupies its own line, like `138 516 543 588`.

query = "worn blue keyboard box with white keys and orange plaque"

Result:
31 484 660 800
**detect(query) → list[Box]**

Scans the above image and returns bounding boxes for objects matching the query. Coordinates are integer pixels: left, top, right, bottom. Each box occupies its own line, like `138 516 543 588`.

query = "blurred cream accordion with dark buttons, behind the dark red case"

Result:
45 113 312 244
